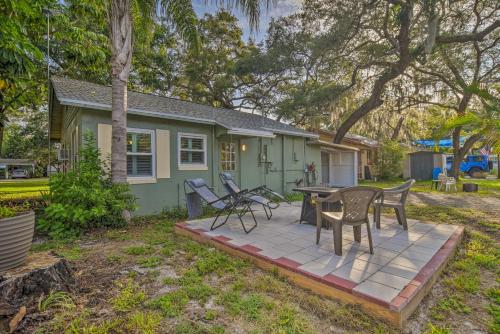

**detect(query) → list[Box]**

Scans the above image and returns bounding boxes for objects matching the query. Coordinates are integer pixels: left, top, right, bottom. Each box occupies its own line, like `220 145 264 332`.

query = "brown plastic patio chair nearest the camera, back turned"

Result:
316 186 382 256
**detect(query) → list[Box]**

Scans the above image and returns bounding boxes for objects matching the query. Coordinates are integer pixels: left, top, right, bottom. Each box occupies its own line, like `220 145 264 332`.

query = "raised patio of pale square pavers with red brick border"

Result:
176 203 463 326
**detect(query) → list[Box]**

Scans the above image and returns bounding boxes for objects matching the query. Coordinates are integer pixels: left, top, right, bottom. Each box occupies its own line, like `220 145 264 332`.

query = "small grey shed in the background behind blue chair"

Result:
404 151 446 180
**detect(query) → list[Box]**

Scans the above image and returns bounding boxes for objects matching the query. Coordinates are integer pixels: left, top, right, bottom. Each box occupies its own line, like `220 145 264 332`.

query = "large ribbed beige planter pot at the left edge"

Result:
0 211 35 272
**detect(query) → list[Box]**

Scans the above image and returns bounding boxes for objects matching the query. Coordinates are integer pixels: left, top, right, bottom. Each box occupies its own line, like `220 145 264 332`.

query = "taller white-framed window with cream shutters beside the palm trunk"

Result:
127 129 154 178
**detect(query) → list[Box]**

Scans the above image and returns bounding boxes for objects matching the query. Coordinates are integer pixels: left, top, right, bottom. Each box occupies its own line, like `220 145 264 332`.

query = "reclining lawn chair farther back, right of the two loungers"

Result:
219 173 286 219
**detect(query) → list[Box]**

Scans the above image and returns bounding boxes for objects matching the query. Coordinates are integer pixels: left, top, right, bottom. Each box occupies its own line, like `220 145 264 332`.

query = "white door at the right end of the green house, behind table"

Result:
330 151 357 187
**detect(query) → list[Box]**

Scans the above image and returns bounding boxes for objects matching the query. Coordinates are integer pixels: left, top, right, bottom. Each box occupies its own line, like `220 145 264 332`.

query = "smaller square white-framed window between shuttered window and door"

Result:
177 133 207 170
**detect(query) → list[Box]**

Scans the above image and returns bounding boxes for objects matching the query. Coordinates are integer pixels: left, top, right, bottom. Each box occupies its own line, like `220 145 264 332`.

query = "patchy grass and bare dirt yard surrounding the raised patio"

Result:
28 205 500 334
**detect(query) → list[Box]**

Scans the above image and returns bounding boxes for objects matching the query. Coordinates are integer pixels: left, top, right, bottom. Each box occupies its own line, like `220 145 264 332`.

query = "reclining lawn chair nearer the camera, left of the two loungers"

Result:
184 178 257 233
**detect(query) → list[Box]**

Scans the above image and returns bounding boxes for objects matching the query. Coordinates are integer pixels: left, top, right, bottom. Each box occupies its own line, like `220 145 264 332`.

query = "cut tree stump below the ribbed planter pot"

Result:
0 252 75 318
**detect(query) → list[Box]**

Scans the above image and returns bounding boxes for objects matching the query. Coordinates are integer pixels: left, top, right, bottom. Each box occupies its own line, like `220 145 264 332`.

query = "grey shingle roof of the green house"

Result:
51 76 317 137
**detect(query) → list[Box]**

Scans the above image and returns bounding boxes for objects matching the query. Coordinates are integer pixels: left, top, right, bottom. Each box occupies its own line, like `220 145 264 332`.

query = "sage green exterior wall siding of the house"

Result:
73 108 321 215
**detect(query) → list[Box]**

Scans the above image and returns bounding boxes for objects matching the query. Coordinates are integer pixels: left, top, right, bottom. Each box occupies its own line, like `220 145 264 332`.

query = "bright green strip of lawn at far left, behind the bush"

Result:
0 178 49 200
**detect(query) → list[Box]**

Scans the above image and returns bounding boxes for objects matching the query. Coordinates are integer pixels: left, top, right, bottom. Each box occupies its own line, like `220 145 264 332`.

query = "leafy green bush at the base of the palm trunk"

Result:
38 132 135 238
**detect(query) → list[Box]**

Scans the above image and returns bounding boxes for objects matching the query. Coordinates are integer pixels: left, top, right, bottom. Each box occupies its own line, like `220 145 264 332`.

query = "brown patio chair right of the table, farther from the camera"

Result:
373 179 415 230
